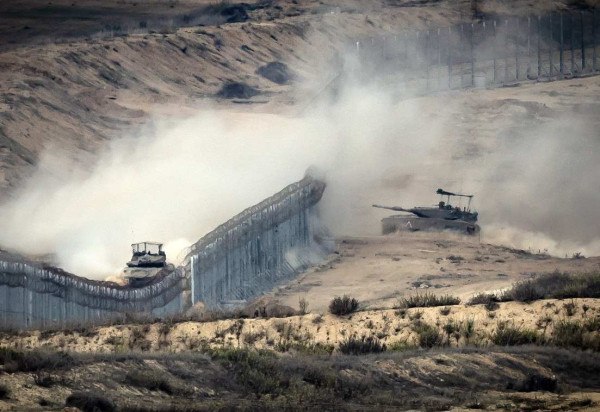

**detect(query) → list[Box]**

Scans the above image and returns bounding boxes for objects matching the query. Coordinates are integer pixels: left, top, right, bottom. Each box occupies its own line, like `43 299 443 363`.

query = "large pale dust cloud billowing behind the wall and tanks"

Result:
0 45 600 278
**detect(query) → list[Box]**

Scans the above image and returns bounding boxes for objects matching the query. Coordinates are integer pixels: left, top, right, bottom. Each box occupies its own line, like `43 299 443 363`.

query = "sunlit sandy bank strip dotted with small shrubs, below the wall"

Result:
0 299 600 353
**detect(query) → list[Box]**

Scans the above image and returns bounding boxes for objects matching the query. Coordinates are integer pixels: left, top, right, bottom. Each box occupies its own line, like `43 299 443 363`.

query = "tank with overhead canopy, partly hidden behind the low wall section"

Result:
123 242 175 287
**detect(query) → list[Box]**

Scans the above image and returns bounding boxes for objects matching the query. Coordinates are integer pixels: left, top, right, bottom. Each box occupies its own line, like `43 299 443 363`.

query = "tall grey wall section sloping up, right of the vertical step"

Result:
186 177 326 308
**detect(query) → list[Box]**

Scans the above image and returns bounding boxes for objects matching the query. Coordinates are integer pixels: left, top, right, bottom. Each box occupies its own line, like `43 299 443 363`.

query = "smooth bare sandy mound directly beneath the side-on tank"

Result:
274 232 600 311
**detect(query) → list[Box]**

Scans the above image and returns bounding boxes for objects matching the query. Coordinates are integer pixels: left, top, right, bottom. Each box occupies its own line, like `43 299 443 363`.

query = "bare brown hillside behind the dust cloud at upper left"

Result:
0 0 585 197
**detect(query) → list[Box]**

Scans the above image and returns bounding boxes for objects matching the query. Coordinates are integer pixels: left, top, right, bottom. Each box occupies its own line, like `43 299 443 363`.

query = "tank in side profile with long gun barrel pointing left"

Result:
373 189 480 235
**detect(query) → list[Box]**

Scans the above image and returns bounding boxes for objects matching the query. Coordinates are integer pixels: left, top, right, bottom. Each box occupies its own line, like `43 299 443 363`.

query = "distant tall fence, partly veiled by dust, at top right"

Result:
353 9 600 91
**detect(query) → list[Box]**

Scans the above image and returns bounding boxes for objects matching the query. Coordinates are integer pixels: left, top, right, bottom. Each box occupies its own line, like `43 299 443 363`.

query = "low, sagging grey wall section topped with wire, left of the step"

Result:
0 261 187 329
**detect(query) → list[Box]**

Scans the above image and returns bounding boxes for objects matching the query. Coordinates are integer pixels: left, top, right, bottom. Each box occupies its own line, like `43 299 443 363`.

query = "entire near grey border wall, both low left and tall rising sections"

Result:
0 173 325 329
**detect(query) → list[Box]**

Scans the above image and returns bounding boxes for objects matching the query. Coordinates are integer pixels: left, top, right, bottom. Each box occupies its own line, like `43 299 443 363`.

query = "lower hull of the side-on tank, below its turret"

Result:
381 215 480 235
